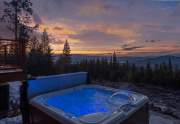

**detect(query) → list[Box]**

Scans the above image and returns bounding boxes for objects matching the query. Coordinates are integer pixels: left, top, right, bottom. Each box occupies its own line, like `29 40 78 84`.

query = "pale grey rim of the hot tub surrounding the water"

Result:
30 85 148 124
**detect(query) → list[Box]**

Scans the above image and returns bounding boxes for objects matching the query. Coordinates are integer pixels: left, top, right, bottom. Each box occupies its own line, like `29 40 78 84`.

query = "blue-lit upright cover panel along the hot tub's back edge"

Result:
28 72 88 98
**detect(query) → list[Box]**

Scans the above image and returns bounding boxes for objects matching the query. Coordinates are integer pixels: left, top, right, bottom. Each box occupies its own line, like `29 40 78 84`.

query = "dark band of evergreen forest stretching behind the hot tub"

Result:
59 54 180 88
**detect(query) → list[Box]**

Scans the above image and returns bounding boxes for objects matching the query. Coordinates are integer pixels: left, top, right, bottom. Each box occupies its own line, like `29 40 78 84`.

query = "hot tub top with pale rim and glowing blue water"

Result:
30 85 148 124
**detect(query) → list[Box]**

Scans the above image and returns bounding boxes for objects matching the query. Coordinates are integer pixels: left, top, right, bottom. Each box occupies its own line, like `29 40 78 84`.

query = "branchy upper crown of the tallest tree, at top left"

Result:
1 0 33 40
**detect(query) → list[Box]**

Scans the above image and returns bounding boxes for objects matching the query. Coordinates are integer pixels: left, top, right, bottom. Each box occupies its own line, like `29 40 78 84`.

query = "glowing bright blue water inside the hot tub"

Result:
46 88 128 117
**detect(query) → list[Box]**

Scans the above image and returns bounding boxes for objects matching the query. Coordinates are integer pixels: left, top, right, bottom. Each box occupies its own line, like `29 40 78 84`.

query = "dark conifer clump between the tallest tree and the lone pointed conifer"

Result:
27 31 54 75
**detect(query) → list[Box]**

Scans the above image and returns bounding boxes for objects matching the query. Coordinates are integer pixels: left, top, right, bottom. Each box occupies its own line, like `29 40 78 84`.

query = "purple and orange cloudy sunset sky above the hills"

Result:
0 0 180 55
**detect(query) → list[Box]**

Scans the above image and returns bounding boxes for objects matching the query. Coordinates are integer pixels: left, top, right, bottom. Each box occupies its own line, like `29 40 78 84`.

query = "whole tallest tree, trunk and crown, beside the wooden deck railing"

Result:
1 0 36 70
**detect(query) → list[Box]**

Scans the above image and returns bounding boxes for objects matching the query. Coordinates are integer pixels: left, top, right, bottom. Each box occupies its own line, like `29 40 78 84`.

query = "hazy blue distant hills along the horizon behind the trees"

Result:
53 54 180 68
